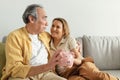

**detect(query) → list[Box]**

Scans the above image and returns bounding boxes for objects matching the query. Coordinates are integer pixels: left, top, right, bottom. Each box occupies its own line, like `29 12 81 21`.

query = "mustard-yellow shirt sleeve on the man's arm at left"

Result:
5 31 31 78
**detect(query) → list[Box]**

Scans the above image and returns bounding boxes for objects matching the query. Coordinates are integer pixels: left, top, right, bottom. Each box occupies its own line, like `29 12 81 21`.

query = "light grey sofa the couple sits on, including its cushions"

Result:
0 35 120 79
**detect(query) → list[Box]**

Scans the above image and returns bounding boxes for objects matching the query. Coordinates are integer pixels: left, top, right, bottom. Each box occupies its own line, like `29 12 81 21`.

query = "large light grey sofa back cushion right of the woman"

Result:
83 36 120 69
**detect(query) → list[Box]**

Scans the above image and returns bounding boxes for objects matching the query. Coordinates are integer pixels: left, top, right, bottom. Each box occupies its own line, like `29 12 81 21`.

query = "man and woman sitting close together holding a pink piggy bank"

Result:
1 4 117 80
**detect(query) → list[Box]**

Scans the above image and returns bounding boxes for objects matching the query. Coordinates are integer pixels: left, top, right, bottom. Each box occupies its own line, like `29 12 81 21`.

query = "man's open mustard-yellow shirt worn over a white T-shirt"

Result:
1 27 50 80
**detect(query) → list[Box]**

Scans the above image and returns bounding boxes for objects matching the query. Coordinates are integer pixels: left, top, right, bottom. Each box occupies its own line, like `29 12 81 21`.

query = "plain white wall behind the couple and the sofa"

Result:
0 0 120 41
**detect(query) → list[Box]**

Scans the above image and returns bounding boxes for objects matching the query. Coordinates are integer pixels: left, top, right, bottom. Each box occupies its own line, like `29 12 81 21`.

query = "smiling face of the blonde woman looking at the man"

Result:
51 20 64 39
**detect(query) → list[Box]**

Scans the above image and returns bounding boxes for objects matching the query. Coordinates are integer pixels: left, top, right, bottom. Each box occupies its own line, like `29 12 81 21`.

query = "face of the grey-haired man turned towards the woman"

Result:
33 8 47 34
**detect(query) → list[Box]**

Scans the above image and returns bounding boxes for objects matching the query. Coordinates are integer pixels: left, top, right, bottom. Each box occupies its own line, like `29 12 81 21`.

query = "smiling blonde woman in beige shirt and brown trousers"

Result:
50 18 117 80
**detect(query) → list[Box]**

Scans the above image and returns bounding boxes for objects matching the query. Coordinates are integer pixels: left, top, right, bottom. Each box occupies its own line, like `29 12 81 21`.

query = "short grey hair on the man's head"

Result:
22 4 43 24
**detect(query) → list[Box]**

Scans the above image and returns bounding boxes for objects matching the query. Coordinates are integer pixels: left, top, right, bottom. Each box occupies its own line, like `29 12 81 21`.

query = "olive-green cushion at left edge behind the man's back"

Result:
0 43 5 78
